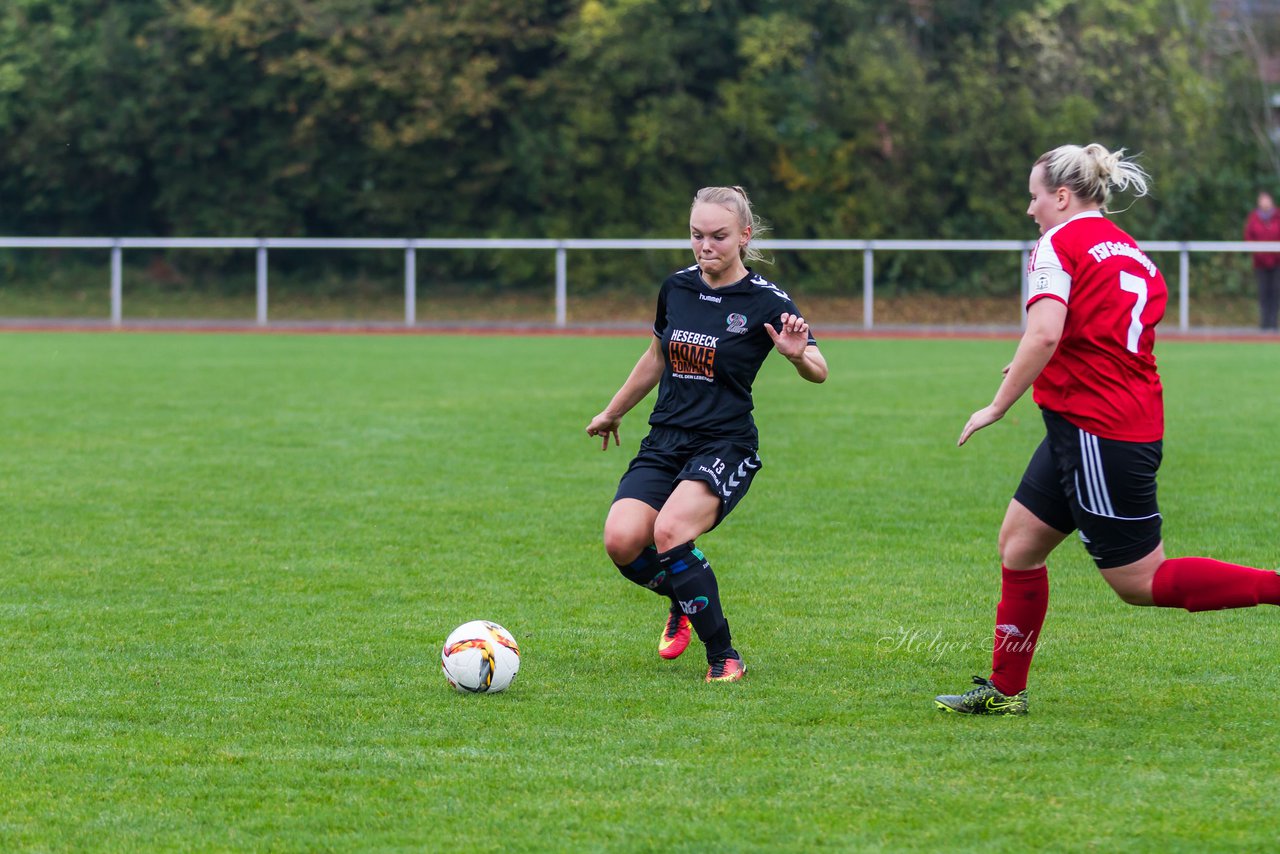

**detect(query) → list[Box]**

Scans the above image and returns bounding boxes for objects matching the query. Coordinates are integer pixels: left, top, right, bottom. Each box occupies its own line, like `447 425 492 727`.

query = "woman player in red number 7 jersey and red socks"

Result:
934 143 1280 714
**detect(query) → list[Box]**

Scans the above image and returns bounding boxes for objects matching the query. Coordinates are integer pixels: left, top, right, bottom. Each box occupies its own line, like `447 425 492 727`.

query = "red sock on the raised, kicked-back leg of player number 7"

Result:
1151 557 1280 611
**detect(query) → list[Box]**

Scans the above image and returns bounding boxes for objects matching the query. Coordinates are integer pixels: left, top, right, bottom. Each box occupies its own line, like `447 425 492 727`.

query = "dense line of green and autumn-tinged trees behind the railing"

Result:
0 0 1277 287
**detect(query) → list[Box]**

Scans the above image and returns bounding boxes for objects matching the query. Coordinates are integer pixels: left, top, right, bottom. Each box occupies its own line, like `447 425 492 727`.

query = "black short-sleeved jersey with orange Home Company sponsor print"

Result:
649 265 817 448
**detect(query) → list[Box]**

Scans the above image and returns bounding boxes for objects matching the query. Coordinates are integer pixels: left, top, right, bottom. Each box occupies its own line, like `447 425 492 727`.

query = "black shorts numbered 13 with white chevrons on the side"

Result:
613 426 763 528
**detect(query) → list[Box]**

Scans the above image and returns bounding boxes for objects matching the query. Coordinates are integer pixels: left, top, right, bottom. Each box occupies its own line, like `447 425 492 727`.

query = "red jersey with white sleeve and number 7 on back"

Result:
1027 211 1169 442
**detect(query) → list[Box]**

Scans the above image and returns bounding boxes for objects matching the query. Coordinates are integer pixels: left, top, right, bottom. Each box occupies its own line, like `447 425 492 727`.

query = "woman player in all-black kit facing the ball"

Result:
586 187 827 682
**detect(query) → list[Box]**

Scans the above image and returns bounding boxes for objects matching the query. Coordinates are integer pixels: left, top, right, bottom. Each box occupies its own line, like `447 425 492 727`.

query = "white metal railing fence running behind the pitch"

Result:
0 237 1280 332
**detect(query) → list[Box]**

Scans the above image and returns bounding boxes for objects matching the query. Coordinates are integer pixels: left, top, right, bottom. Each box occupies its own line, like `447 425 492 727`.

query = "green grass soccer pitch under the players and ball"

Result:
0 330 1280 851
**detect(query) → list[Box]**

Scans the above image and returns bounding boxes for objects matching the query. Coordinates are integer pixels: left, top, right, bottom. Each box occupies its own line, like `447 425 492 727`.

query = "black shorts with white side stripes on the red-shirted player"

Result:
1014 410 1164 570
